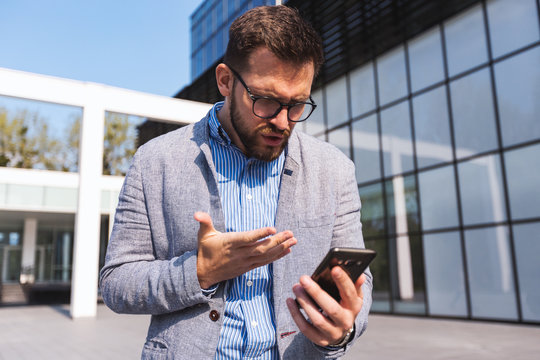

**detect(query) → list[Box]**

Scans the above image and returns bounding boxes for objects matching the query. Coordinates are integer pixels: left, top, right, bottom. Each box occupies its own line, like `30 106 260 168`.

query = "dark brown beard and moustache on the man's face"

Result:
229 87 291 162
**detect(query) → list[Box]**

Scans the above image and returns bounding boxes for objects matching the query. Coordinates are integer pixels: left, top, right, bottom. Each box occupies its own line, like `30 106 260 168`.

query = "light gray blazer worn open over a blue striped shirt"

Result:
100 113 372 359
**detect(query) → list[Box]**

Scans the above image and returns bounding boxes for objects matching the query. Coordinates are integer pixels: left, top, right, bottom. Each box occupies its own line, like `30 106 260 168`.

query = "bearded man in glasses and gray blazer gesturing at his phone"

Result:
100 6 371 359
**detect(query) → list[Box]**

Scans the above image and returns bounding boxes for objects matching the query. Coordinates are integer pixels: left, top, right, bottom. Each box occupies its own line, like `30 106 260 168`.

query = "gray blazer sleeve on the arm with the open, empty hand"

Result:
100 151 209 315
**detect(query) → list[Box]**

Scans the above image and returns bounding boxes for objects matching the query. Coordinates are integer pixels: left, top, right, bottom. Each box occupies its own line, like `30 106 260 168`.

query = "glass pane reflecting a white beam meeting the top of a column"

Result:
381 101 414 176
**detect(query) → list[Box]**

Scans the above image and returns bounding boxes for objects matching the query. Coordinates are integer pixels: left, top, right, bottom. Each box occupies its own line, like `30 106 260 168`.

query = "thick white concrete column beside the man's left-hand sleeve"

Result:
70 84 105 319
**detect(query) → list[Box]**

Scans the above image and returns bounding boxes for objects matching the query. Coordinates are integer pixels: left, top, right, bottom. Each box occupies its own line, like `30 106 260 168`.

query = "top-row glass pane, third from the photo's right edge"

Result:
409 27 444 92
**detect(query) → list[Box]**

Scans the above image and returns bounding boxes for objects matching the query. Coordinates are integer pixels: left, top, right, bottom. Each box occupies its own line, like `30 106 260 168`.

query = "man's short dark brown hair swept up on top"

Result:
224 5 324 75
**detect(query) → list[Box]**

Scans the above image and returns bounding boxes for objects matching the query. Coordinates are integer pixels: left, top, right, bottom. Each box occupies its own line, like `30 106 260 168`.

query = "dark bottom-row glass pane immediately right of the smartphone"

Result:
365 239 390 312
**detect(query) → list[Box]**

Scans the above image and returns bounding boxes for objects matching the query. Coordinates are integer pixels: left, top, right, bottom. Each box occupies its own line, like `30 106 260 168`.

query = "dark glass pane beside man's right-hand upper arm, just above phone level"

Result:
358 183 384 238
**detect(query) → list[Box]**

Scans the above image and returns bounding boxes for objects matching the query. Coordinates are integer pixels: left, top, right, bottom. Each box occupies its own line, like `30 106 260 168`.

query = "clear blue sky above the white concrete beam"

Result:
0 0 202 96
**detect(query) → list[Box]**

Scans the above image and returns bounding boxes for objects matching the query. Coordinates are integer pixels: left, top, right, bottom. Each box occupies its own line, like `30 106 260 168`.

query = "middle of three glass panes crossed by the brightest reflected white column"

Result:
385 175 420 235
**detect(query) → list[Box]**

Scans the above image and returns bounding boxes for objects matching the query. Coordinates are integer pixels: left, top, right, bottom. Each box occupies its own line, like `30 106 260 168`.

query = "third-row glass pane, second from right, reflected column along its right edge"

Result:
458 155 506 225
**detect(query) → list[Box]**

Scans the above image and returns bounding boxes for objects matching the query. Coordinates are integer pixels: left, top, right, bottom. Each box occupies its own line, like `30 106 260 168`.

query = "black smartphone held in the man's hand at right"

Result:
311 247 377 302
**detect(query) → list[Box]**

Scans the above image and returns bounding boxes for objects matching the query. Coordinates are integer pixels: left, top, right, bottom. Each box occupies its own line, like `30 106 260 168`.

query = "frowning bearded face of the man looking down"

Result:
229 48 314 161
